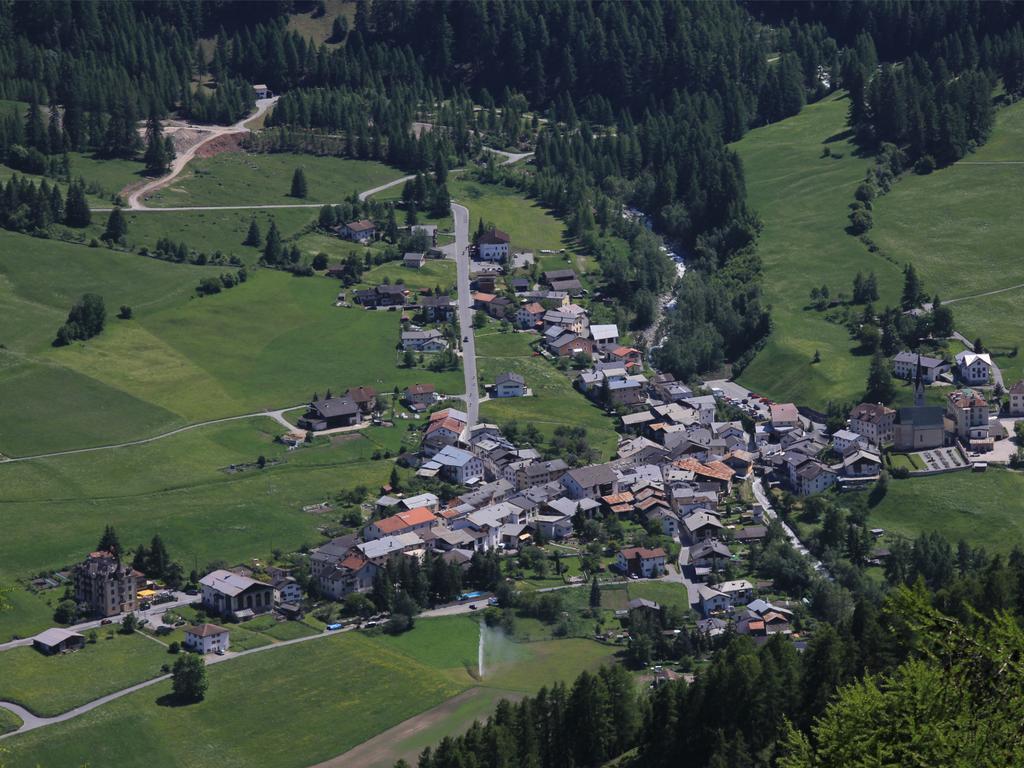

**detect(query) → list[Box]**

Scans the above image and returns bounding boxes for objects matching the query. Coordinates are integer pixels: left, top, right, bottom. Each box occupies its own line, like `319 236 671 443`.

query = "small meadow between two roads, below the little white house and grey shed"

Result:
0 630 165 717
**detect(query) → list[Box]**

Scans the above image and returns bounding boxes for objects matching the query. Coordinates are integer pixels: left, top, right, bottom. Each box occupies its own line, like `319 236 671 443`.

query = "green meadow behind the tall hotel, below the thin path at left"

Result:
0 418 399 626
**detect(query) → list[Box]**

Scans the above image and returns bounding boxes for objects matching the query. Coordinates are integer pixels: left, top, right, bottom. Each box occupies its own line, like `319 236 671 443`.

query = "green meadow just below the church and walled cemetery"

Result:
870 468 1024 554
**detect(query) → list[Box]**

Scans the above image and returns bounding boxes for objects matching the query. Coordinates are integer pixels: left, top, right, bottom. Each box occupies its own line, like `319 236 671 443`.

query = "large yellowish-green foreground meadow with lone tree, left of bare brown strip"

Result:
4 634 466 768
